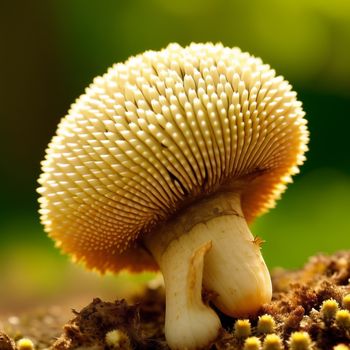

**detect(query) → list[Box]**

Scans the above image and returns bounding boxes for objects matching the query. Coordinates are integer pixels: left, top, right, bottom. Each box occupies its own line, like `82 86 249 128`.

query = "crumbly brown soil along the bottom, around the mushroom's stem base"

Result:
0 251 350 350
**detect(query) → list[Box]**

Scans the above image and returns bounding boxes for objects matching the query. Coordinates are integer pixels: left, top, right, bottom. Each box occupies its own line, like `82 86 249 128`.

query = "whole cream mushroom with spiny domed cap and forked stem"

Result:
38 43 308 349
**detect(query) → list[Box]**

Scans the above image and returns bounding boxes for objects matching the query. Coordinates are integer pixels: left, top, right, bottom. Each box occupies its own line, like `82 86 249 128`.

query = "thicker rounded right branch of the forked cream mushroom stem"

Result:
203 197 272 317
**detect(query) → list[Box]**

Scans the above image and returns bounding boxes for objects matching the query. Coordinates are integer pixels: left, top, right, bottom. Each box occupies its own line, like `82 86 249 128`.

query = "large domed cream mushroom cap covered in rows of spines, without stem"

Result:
38 43 308 272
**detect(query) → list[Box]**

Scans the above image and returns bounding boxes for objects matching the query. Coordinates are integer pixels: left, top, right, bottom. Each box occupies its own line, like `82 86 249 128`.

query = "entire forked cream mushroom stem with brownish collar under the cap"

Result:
144 193 272 349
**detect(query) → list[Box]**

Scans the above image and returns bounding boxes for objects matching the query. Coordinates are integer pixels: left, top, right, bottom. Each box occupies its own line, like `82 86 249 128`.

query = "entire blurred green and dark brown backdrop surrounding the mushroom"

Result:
0 0 350 312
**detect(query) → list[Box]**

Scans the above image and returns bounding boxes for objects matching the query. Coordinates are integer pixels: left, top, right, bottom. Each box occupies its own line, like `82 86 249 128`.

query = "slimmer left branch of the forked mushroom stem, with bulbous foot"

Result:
150 235 221 349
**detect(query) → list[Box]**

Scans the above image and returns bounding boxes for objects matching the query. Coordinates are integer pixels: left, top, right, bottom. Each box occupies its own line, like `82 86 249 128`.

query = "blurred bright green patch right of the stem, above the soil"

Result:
252 169 350 268
